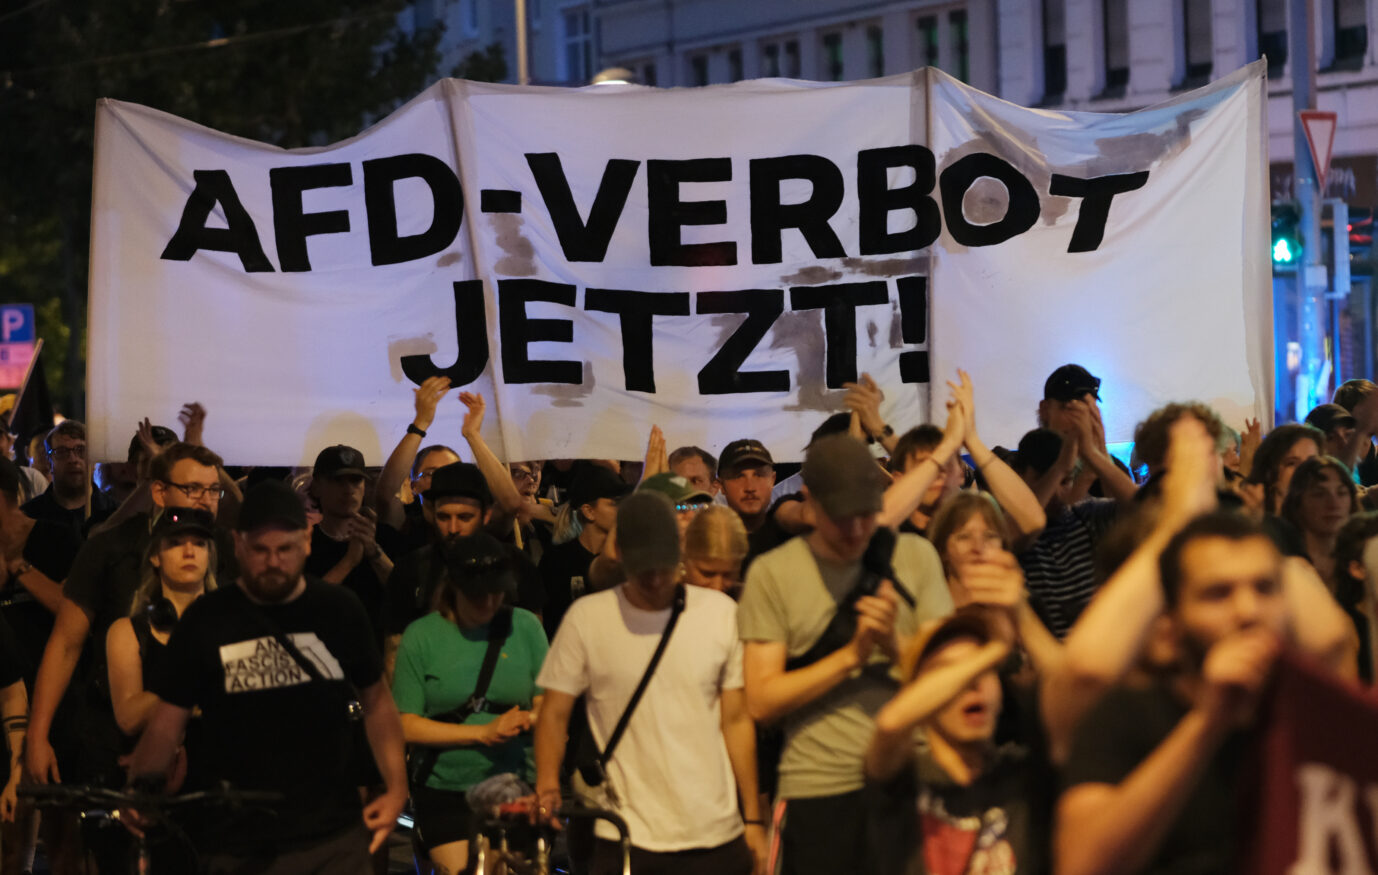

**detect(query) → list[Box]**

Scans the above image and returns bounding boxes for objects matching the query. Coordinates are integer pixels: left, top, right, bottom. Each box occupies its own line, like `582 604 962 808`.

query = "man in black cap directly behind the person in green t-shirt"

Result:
383 462 546 674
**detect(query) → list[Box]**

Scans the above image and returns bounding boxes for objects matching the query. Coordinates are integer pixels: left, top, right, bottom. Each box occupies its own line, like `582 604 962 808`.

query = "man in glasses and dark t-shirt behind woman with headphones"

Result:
25 442 238 815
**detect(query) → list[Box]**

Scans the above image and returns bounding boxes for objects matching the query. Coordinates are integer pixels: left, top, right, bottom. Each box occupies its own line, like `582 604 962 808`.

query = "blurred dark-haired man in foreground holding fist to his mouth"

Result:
1054 511 1295 874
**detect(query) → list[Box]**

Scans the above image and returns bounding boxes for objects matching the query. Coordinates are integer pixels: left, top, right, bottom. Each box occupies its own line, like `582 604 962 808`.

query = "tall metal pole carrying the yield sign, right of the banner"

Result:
1287 0 1327 420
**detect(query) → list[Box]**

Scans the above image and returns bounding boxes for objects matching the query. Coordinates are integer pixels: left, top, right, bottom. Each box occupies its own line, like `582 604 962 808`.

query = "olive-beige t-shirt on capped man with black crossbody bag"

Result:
737 535 952 799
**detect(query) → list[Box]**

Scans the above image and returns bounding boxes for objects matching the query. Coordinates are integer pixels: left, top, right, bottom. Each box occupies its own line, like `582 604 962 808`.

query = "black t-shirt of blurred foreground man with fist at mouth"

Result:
1062 683 1248 875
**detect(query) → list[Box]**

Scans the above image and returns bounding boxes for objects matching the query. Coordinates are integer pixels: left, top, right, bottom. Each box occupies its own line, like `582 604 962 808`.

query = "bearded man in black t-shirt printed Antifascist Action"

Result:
130 481 407 875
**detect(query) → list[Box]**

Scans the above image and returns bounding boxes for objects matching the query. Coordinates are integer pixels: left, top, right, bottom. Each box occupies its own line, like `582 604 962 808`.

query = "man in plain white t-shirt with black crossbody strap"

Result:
536 492 766 875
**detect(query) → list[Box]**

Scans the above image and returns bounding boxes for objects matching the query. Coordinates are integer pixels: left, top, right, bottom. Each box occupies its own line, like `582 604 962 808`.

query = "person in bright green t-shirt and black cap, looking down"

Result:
393 532 548 872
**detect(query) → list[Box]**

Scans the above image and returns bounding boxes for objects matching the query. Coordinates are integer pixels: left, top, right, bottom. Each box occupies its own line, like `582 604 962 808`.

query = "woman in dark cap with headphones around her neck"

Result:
105 507 216 737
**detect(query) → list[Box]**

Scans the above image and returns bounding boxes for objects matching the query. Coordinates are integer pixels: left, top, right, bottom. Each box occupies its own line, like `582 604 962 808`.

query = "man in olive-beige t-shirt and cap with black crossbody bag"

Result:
737 434 952 875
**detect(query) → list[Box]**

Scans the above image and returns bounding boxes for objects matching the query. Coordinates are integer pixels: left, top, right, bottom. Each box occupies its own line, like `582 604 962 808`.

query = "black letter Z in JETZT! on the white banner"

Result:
695 288 790 395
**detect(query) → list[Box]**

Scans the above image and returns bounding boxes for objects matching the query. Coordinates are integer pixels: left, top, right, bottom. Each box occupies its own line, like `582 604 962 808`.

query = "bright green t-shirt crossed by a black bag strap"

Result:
393 608 550 791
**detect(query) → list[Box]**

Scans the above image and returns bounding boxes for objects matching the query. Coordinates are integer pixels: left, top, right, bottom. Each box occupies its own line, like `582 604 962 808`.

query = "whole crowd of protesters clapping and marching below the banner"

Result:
0 364 1378 875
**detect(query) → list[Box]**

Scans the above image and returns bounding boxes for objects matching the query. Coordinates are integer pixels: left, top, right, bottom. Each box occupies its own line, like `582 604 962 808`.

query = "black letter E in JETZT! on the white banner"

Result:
497 280 584 386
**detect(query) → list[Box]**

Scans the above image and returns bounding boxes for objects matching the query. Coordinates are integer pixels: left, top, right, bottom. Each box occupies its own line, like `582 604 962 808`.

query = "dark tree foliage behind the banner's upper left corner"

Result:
0 0 441 426
